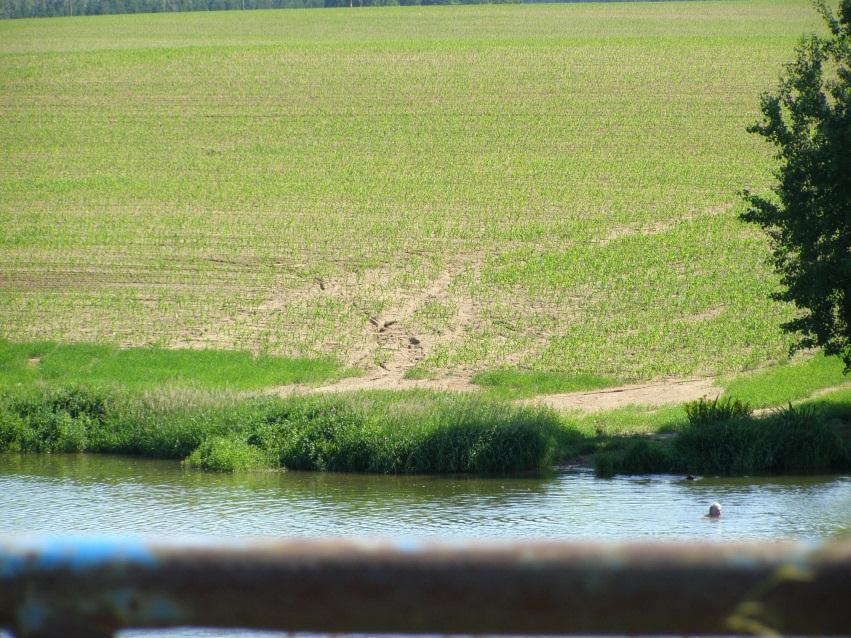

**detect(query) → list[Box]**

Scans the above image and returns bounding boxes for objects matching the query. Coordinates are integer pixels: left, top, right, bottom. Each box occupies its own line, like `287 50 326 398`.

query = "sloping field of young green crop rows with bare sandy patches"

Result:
0 0 821 381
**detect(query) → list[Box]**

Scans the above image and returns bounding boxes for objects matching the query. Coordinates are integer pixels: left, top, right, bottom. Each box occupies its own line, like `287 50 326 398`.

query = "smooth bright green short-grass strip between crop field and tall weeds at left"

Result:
0 339 355 390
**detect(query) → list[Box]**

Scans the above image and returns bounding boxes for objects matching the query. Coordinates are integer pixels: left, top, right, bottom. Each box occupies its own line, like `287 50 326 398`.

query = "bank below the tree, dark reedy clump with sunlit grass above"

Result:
572 354 851 475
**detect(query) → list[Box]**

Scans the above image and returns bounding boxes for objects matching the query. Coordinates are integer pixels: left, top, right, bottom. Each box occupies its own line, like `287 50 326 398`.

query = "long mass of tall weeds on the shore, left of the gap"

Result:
0 387 562 474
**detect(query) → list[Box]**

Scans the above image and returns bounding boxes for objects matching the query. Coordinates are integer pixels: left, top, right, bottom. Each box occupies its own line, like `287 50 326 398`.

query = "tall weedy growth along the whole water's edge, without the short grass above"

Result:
0 378 851 475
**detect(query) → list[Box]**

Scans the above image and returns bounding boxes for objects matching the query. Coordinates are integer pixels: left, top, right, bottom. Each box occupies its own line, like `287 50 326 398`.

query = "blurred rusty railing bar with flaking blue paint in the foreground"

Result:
0 538 851 638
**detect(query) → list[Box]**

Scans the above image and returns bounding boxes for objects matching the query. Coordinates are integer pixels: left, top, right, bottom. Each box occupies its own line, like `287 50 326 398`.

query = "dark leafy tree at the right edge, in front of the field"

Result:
742 0 851 374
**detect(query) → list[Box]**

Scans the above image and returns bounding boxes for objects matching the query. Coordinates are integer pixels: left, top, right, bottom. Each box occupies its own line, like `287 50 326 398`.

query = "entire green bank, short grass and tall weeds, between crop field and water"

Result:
0 341 851 475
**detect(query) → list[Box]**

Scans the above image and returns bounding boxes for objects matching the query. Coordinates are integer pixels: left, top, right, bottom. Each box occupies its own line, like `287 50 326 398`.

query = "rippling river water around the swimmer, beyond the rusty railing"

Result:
0 455 851 638
